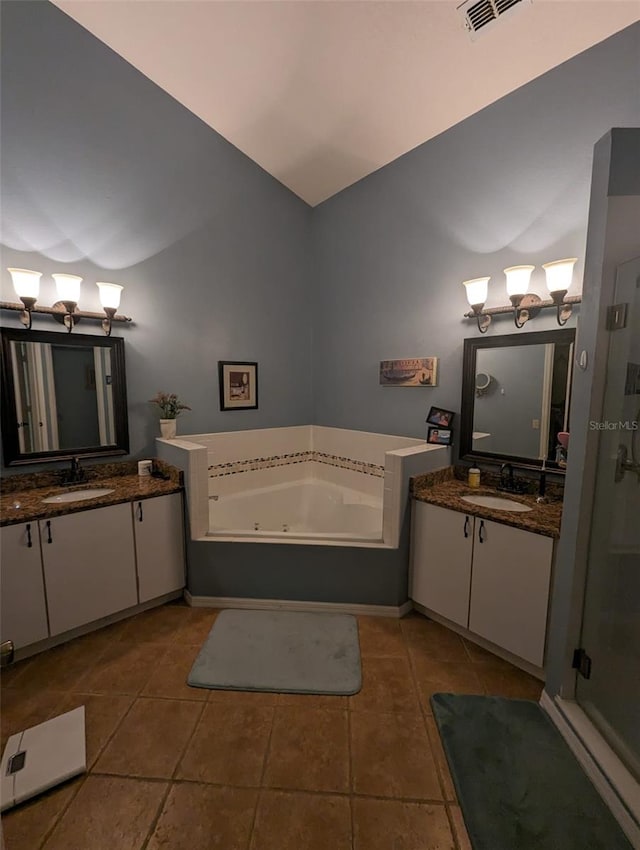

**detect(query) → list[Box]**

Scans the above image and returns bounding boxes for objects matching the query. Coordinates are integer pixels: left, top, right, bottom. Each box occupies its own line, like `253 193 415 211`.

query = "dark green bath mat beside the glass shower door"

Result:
431 694 631 850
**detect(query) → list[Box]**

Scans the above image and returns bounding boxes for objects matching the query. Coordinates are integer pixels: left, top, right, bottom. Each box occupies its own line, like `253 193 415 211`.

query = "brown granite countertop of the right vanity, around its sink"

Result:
411 467 562 539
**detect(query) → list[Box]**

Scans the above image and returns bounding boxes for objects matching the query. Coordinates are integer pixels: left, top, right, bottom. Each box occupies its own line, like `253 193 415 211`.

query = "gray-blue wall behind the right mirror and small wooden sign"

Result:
313 25 640 437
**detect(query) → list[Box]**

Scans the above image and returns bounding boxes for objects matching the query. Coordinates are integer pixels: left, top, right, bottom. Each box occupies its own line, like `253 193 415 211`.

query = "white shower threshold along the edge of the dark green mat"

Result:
540 691 640 847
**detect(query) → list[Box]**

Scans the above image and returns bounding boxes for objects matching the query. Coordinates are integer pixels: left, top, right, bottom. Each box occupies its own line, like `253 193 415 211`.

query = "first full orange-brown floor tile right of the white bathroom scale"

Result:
95 697 203 779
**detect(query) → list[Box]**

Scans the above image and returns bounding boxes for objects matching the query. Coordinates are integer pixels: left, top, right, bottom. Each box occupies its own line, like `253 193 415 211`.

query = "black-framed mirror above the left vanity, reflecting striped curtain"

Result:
1 328 129 466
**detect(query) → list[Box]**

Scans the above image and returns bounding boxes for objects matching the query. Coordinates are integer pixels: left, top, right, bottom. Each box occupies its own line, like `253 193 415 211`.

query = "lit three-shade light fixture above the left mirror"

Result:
0 269 131 336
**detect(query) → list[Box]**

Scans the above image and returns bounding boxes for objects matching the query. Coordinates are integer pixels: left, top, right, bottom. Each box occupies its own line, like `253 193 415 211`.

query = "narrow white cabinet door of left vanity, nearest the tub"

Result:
131 493 185 602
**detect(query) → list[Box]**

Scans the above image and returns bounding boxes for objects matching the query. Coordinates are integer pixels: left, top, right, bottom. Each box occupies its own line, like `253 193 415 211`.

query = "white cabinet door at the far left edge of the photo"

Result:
0 522 49 649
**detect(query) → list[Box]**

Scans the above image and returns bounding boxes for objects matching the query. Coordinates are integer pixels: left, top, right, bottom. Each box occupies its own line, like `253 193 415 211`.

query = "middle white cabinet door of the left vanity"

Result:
40 502 138 635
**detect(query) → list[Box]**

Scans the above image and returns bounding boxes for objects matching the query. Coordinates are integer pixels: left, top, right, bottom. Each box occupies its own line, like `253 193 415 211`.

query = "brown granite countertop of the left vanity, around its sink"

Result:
0 461 183 526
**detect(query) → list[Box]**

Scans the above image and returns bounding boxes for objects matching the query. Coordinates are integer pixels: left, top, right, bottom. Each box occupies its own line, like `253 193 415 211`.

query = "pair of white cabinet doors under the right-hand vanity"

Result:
410 502 553 667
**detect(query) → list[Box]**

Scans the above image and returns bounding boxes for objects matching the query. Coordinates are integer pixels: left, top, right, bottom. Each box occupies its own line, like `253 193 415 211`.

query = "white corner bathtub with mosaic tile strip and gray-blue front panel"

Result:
157 425 450 606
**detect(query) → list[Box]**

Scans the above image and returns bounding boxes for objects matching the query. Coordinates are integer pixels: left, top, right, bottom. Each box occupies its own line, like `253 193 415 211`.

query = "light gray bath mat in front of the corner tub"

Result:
187 610 362 695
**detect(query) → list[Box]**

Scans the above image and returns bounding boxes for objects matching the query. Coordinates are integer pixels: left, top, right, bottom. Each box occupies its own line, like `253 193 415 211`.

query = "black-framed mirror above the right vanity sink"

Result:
460 328 575 472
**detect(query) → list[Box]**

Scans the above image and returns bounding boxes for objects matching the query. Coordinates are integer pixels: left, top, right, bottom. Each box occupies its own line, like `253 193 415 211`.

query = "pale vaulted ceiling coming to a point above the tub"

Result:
53 0 640 206
